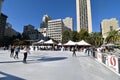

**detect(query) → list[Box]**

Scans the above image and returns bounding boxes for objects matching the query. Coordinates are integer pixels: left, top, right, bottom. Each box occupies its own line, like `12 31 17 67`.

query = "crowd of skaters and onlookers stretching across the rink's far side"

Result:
0 45 96 63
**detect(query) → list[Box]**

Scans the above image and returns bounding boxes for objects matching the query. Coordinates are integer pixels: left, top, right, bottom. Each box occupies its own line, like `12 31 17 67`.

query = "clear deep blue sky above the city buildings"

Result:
2 0 120 33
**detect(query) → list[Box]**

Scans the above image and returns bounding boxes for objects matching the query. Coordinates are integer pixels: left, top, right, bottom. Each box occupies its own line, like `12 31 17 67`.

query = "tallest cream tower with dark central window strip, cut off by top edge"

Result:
76 0 92 33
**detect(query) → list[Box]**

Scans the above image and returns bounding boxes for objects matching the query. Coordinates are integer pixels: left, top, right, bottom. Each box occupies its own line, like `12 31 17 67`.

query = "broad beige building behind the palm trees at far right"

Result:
101 18 119 39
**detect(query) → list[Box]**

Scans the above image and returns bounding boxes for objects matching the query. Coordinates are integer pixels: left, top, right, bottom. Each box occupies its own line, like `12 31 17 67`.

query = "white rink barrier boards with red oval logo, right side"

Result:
96 52 120 75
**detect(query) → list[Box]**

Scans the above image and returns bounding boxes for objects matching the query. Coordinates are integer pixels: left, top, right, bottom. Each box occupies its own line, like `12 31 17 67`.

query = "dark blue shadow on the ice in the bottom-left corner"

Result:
0 71 25 80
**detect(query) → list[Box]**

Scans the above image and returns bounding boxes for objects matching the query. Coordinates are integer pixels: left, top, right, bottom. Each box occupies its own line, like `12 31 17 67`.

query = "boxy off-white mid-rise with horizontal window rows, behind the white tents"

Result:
47 19 64 42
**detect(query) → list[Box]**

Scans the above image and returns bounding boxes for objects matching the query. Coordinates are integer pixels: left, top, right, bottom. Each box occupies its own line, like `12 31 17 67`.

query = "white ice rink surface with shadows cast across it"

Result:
0 50 120 80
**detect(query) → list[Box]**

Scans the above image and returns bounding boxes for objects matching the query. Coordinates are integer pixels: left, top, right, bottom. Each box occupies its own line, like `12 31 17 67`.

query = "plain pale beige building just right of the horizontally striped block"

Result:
63 17 73 31
